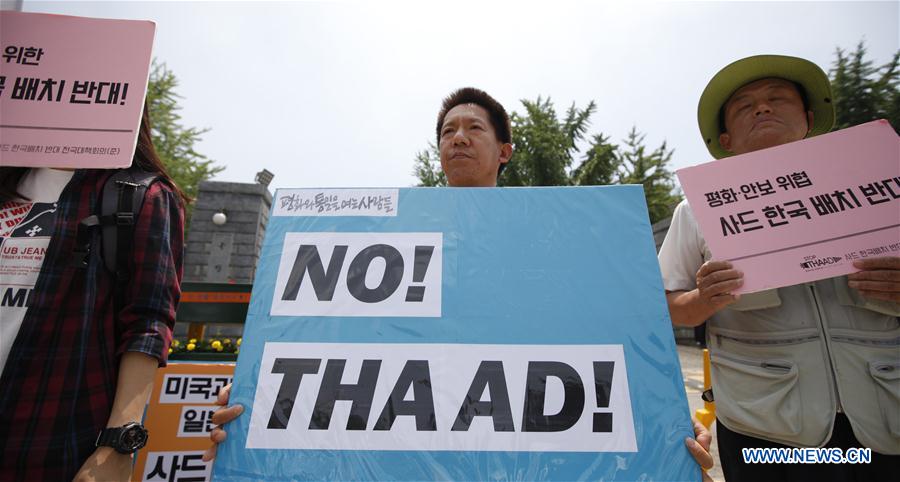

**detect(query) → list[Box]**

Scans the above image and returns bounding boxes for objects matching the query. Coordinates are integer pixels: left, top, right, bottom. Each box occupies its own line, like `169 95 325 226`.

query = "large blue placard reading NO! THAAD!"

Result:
214 186 700 480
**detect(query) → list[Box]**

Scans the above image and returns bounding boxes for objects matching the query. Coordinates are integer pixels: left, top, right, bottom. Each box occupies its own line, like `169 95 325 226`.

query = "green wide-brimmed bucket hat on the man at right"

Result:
697 55 834 159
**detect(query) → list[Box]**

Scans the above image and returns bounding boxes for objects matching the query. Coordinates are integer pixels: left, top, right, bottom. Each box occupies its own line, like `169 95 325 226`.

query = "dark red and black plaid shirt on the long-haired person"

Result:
0 170 184 481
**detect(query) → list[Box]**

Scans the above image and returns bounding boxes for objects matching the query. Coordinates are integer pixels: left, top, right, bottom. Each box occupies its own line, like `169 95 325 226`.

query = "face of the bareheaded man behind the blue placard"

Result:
439 104 512 187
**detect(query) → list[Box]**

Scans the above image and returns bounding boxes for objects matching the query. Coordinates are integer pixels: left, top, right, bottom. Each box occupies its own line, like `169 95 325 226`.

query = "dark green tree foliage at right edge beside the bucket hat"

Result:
830 42 900 132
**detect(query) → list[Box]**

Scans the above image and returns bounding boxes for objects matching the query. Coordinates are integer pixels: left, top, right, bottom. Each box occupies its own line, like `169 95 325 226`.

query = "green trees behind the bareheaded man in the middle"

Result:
413 97 681 223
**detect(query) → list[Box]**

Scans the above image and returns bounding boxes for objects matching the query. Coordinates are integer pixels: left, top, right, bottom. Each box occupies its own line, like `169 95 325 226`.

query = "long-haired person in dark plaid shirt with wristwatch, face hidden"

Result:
0 104 188 480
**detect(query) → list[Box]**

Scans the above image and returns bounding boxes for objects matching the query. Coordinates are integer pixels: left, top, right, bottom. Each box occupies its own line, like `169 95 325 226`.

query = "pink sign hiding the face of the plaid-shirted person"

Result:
0 11 156 168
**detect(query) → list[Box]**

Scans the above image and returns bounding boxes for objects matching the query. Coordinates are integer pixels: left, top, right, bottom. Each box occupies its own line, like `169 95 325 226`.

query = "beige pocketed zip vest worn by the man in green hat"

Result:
707 277 900 454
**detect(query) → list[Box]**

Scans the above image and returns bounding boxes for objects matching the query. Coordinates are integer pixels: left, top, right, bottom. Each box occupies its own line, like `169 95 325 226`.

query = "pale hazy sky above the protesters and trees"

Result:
14 0 900 188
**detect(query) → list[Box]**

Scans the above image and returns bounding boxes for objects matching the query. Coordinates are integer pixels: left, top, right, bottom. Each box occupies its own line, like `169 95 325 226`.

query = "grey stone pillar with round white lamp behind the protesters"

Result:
184 181 272 284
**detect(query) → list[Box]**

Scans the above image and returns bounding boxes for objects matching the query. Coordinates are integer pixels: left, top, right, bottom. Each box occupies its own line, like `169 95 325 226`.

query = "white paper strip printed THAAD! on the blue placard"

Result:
247 343 637 452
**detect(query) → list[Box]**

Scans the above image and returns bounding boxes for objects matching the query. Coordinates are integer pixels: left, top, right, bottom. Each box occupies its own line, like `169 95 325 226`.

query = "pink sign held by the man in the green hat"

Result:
677 120 900 293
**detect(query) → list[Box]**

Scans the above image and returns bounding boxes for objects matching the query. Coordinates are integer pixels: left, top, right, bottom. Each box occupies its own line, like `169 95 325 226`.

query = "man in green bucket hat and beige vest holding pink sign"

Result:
659 55 900 482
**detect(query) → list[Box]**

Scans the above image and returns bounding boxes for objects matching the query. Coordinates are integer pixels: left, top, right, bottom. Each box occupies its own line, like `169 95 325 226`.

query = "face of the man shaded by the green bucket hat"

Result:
719 78 813 154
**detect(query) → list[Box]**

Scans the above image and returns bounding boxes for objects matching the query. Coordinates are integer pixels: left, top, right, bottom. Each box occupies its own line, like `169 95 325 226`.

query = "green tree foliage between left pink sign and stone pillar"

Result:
147 61 225 211
